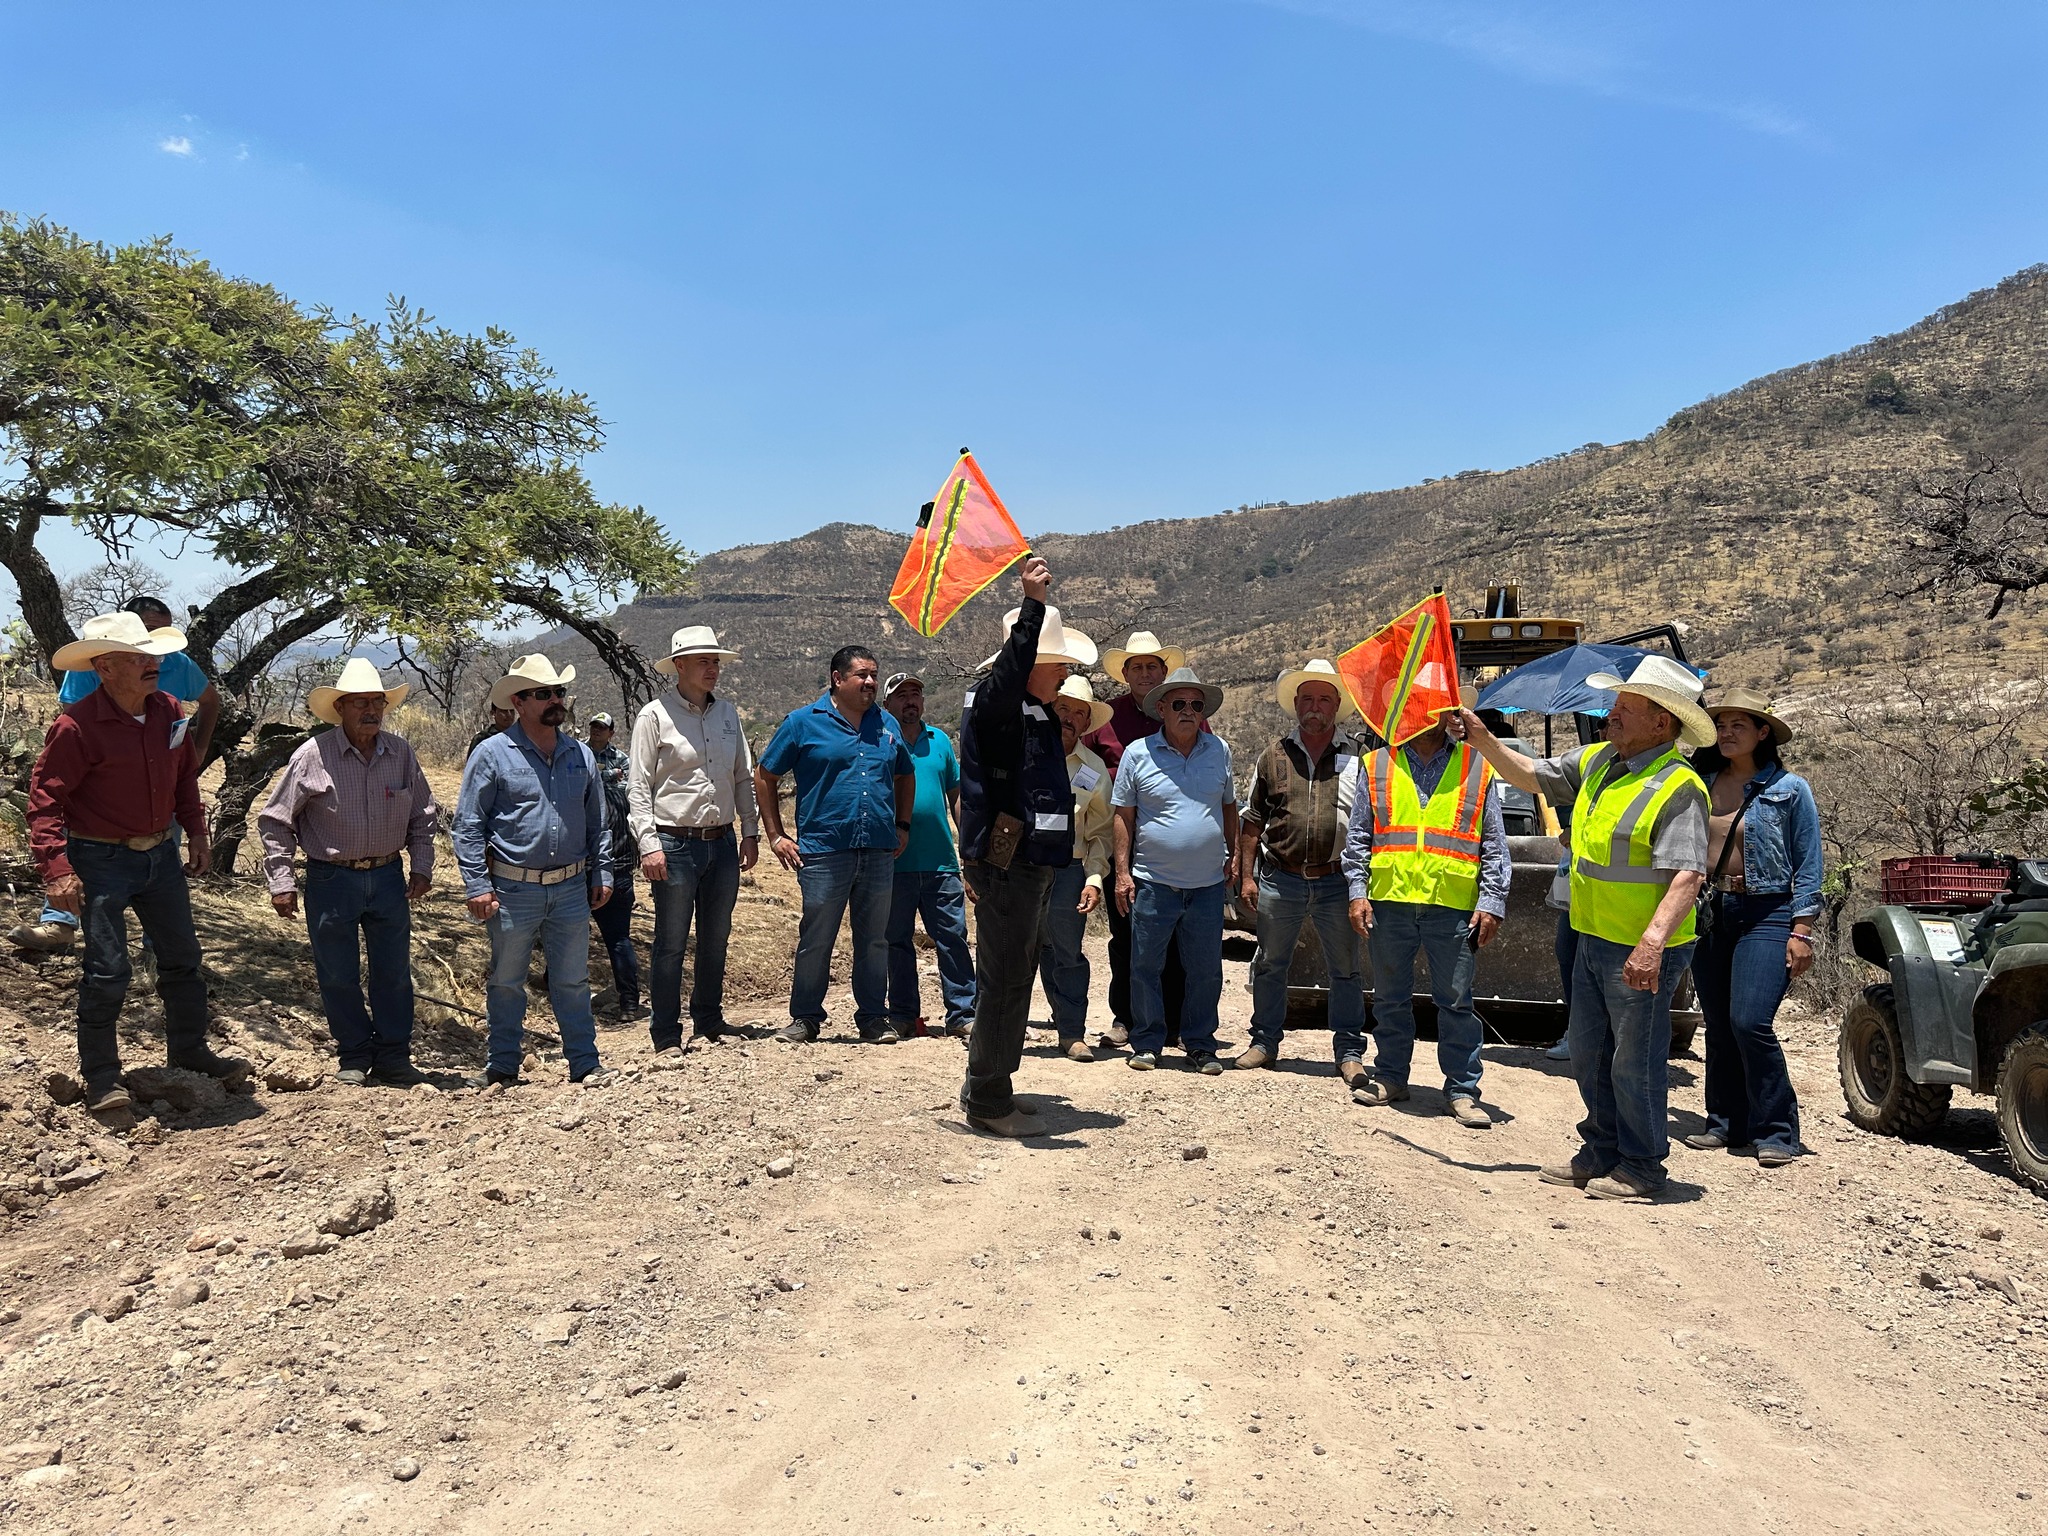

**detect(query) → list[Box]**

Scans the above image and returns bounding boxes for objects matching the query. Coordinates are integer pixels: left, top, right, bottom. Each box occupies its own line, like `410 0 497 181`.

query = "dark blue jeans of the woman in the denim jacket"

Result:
1692 895 1798 1153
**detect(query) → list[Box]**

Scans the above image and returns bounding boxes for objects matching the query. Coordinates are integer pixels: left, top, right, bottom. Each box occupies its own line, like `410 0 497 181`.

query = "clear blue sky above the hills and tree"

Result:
0 0 2048 589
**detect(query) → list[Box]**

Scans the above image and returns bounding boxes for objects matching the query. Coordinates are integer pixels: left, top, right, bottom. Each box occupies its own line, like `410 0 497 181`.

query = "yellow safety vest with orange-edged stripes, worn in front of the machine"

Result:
1364 741 1493 911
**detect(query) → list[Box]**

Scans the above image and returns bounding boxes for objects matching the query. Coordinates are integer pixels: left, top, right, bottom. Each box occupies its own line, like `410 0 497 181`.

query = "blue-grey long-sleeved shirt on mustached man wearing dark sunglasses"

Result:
453 721 612 895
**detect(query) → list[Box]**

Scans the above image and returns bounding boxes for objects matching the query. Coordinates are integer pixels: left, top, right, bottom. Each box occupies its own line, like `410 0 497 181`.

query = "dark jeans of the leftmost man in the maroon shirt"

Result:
66 838 207 1087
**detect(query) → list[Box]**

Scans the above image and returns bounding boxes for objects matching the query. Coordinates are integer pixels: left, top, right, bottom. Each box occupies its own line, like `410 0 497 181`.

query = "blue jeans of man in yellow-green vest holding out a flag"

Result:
1569 934 1692 1188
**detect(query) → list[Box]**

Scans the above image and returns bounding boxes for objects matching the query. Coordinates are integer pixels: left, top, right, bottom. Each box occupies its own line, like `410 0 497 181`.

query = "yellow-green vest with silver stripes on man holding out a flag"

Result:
1571 741 1706 948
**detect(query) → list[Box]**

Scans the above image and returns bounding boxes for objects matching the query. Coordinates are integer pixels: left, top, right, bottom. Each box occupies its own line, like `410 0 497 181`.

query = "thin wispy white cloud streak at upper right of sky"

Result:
1247 0 1810 137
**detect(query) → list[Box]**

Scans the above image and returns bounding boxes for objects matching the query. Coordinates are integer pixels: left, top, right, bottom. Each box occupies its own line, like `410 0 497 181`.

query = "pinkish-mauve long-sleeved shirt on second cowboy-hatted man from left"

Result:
256 729 440 895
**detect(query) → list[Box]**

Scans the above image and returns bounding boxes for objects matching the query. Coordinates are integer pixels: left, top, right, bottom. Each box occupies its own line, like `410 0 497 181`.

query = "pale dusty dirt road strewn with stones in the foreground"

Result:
0 888 2048 1536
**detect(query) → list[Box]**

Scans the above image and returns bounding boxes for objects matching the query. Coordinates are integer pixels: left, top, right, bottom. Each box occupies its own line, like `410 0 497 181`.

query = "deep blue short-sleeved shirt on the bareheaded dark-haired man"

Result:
760 692 913 856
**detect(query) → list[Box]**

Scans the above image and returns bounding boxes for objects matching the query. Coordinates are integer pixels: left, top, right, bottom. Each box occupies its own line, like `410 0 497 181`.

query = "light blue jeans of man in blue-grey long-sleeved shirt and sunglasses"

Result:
483 879 598 1077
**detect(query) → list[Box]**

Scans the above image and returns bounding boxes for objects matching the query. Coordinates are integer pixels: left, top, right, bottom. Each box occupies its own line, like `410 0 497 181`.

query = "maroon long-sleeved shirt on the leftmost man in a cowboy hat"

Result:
29 688 207 883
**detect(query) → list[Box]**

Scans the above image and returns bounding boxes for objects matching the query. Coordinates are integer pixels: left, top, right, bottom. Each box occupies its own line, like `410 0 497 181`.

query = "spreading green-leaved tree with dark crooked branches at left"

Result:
0 215 692 870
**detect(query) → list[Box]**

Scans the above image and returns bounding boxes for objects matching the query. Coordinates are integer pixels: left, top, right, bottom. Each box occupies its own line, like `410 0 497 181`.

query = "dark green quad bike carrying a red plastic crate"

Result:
1839 854 2048 1194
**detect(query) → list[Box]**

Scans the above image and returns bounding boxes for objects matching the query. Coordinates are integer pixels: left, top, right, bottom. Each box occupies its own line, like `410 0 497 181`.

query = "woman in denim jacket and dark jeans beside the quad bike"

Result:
1686 688 1821 1167
